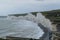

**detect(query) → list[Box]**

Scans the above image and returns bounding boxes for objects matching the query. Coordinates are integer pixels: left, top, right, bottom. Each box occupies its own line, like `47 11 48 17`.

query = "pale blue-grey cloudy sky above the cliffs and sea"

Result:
0 0 60 16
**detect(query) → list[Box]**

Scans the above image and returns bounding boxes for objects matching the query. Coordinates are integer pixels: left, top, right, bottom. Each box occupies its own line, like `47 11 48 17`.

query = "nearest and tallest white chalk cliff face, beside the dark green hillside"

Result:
36 13 52 31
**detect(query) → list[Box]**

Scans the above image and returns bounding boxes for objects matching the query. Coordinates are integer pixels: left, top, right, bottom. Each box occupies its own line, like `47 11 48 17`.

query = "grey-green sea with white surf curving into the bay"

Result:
0 18 44 39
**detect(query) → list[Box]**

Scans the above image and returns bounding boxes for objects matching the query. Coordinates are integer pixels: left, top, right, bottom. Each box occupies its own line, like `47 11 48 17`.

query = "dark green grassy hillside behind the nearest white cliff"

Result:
41 10 60 23
